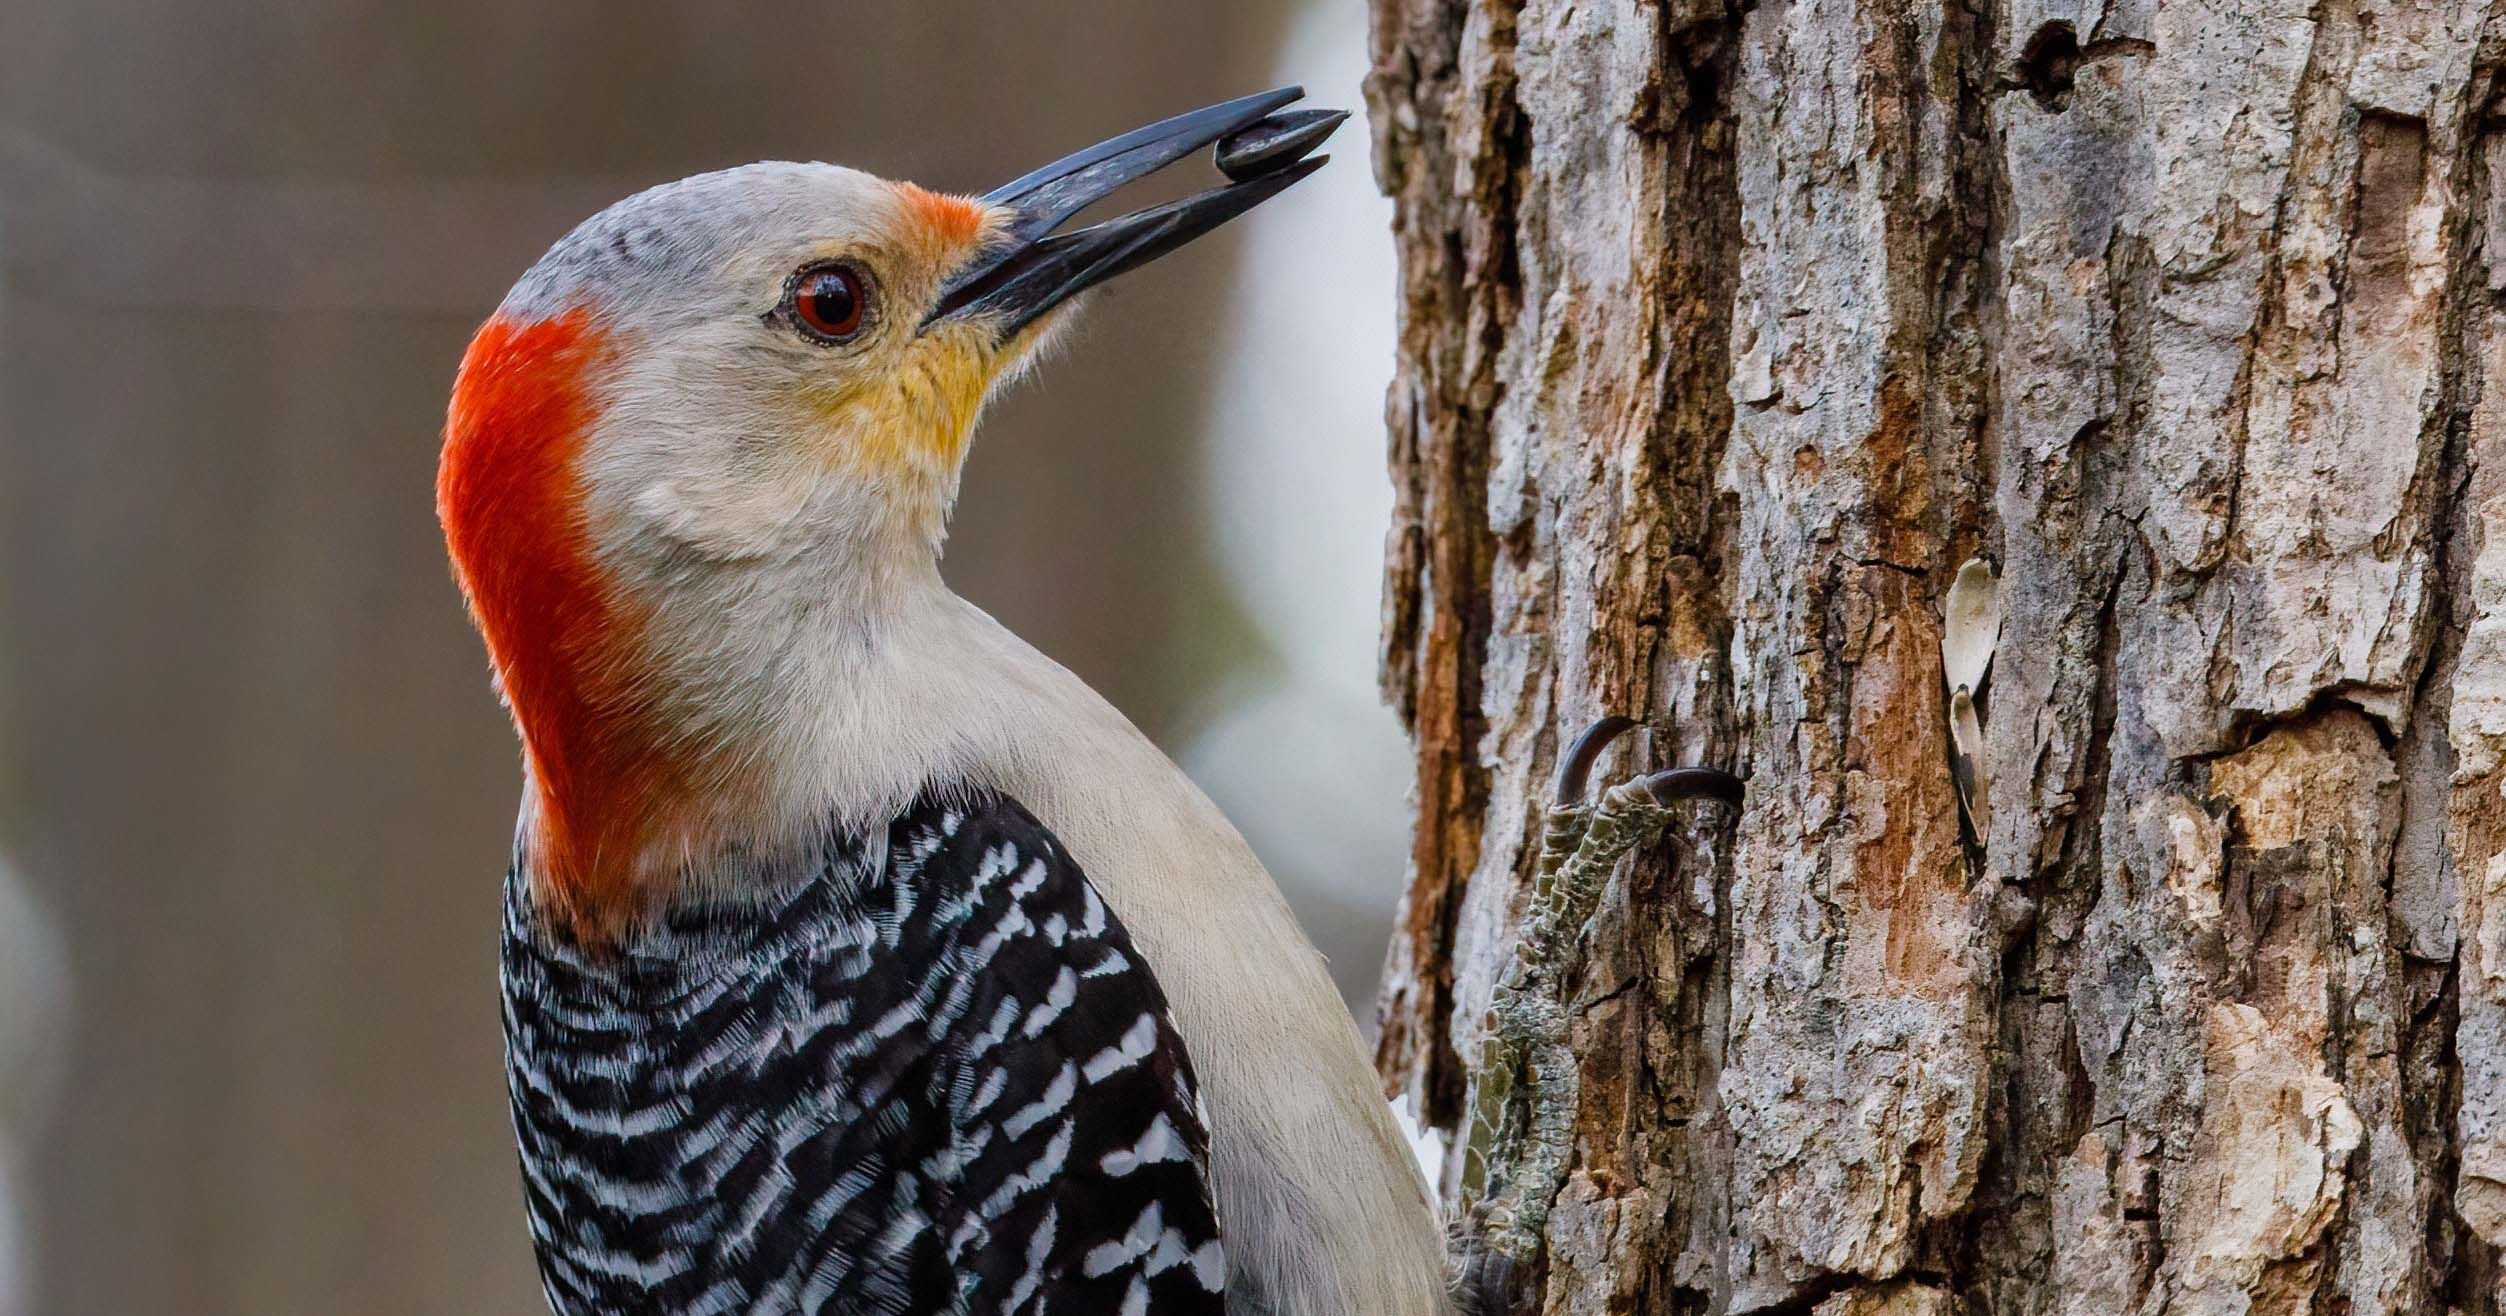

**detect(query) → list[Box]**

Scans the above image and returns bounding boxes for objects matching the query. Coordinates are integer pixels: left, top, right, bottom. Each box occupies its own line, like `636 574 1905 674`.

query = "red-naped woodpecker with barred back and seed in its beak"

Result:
436 88 1446 1316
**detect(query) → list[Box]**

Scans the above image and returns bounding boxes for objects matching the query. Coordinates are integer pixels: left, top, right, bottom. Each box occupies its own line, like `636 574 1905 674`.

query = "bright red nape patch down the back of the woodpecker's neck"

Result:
436 308 677 937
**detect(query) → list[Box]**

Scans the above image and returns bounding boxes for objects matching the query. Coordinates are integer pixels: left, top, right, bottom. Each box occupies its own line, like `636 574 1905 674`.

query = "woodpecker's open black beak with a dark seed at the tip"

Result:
922 88 1348 341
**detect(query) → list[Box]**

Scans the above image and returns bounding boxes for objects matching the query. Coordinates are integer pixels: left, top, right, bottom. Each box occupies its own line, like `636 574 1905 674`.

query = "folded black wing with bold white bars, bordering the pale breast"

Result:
890 797 1225 1316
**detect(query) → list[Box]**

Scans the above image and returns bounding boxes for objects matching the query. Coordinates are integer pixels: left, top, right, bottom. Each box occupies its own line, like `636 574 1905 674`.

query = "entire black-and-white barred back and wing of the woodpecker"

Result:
504 795 1225 1316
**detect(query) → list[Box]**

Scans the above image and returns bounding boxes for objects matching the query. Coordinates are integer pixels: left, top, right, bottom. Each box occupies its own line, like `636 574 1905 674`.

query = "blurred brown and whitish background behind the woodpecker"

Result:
0 0 1408 1316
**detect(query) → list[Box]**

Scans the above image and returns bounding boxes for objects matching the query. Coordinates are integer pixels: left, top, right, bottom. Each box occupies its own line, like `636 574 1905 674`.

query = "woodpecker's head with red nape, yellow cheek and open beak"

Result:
436 88 1338 932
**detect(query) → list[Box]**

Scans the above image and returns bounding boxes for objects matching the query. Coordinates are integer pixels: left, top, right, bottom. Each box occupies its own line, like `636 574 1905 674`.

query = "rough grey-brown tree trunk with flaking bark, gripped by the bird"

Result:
1368 0 2506 1316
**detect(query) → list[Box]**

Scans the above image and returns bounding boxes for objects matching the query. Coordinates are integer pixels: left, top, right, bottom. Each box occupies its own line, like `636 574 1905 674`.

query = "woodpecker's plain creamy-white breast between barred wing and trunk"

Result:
787 582 1446 1316
